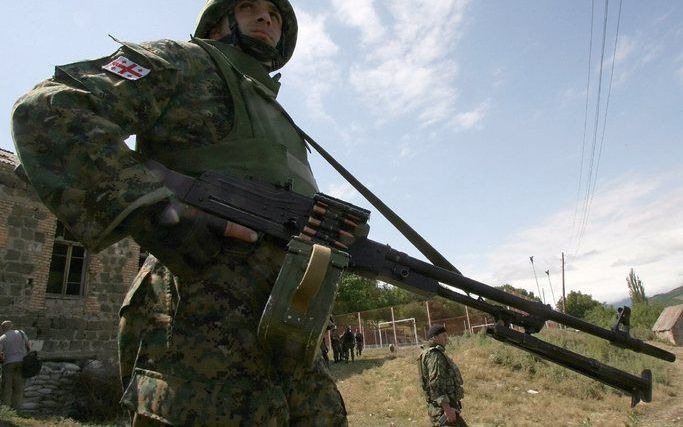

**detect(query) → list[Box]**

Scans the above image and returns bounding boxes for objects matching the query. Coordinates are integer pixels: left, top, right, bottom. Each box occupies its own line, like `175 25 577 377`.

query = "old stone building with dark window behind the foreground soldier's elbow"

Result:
0 150 140 363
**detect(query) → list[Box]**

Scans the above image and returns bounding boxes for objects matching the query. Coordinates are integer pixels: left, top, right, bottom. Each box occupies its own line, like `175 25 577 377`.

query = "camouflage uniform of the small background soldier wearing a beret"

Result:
418 344 466 426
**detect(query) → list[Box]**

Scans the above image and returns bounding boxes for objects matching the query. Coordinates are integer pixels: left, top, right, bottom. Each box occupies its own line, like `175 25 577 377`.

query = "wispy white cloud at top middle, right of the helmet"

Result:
333 0 476 126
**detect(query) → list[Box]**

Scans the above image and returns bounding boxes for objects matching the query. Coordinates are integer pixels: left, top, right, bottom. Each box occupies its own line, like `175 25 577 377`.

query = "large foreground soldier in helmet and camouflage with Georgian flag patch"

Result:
12 0 347 426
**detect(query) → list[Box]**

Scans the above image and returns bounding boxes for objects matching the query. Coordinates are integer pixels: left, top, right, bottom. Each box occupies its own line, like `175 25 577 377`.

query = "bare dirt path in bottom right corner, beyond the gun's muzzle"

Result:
634 343 683 427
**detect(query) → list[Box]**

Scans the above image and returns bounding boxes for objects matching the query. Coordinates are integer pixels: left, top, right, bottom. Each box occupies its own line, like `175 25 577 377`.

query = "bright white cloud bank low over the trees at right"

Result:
481 174 683 301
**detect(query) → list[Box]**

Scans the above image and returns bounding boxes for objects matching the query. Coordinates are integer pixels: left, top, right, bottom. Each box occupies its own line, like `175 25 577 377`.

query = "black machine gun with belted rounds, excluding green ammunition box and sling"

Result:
146 161 676 406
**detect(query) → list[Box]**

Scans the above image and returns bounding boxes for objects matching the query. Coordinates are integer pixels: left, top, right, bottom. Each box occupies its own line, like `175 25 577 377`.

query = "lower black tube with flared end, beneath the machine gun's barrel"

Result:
486 323 652 407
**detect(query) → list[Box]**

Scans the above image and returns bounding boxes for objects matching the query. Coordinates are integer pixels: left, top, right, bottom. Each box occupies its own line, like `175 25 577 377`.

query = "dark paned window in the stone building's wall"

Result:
47 222 87 296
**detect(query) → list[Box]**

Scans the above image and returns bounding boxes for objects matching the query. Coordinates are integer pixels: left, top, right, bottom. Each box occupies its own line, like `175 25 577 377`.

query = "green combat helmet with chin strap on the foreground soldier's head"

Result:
194 0 298 71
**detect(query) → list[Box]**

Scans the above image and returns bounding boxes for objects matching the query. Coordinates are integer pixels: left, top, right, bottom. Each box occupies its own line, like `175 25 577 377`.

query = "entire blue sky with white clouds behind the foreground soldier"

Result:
0 0 683 301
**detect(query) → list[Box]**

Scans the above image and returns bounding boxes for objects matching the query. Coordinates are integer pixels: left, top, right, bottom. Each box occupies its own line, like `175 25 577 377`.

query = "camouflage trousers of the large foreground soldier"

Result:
119 244 347 426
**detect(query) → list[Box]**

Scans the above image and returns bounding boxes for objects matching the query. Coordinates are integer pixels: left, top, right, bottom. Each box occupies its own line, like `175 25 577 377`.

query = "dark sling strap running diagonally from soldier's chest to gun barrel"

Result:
273 100 462 274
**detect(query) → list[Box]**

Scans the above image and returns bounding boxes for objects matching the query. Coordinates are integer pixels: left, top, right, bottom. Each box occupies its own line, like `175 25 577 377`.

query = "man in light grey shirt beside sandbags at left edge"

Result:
0 320 31 410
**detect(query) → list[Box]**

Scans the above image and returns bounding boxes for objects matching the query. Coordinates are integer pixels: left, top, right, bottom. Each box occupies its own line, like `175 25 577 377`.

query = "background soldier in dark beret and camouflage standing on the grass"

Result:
418 325 467 427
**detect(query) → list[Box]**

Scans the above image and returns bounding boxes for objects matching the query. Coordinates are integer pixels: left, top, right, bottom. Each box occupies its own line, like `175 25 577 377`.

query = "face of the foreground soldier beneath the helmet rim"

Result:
235 0 282 47
